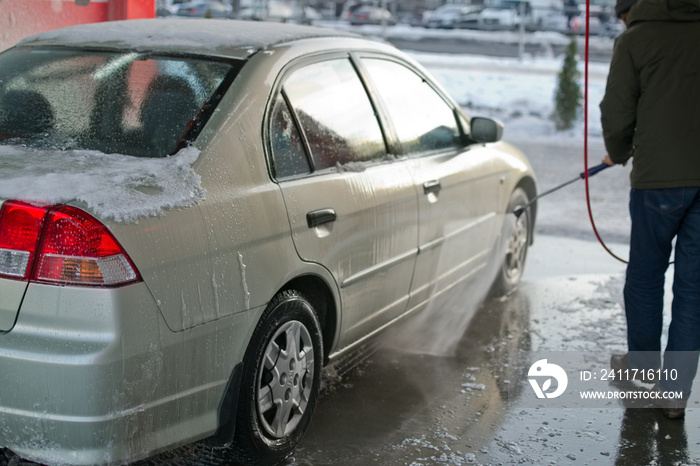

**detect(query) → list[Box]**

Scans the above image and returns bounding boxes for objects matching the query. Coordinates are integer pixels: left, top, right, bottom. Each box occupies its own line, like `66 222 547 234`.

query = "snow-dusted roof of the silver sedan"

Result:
18 18 358 58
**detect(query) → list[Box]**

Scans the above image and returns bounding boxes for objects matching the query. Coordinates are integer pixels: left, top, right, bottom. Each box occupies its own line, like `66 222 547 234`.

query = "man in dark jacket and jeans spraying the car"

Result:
600 0 700 418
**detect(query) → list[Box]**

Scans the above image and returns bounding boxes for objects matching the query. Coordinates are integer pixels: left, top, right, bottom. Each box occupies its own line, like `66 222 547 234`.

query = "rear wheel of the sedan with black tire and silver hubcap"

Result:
231 291 323 465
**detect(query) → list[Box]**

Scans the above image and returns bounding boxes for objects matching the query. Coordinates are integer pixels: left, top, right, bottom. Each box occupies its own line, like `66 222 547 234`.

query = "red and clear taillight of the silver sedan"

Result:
0 201 140 286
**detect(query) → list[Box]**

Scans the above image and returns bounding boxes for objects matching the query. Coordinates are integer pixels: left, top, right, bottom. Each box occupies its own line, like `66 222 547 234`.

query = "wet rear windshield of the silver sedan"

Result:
0 48 241 157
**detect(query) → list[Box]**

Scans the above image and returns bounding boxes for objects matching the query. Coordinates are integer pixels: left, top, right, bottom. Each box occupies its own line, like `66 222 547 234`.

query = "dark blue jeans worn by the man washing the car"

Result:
624 187 700 400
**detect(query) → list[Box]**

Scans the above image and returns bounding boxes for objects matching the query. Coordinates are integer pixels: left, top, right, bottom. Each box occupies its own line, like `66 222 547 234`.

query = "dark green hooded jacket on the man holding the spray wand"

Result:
600 0 700 189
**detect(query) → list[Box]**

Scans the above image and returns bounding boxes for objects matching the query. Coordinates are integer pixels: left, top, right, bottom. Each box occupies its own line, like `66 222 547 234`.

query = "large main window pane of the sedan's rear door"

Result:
283 59 386 170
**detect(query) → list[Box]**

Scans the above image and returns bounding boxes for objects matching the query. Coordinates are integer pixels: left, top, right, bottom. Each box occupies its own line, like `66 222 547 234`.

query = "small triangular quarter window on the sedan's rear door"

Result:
270 93 311 178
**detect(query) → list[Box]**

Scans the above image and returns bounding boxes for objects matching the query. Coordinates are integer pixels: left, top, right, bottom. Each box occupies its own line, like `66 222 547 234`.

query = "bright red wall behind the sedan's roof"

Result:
0 0 156 50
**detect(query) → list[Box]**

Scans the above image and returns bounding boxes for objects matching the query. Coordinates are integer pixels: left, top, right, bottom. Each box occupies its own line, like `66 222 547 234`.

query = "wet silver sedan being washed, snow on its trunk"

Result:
0 19 536 465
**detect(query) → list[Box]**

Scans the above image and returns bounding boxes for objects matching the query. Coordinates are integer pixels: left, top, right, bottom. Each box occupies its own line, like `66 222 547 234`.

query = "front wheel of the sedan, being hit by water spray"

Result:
490 188 532 296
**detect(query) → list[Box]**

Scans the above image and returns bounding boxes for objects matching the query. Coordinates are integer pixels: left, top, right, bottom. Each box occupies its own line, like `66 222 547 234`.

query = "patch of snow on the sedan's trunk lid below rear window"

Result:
0 146 206 222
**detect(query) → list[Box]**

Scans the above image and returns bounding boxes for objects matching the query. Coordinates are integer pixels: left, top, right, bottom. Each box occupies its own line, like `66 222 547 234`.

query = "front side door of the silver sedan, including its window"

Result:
361 56 500 308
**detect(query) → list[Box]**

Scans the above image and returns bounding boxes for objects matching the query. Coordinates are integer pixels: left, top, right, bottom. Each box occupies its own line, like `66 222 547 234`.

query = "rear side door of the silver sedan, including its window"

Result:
270 56 418 347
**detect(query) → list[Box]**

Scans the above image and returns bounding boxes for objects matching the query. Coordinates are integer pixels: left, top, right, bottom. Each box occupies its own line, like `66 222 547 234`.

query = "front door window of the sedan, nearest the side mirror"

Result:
362 58 461 155
